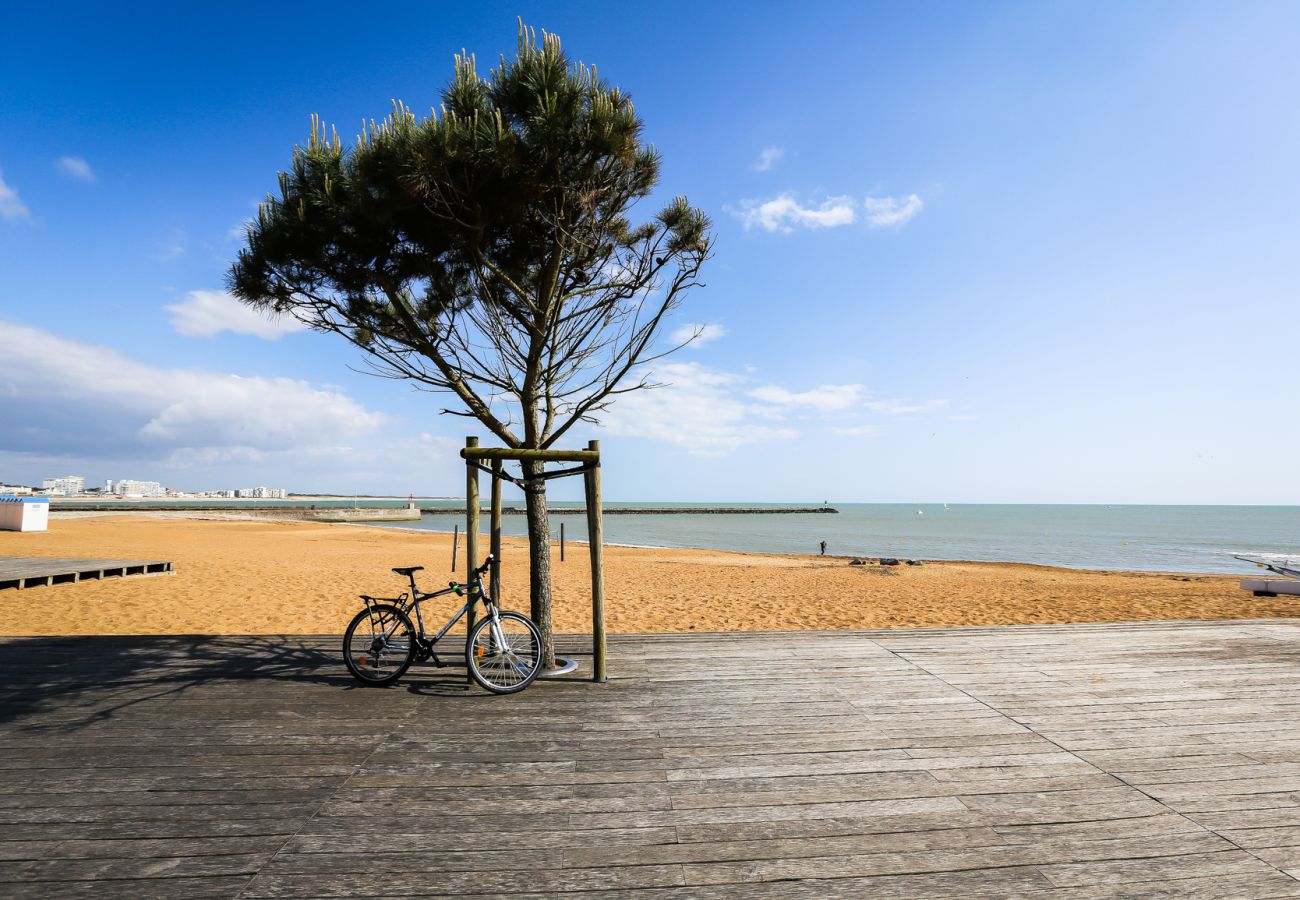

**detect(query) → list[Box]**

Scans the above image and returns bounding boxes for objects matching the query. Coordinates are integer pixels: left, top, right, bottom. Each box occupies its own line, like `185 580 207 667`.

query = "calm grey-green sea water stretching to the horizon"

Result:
369 501 1300 574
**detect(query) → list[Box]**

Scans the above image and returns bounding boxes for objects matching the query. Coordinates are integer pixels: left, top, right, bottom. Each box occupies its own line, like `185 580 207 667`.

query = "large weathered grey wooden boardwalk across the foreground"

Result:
0 621 1300 899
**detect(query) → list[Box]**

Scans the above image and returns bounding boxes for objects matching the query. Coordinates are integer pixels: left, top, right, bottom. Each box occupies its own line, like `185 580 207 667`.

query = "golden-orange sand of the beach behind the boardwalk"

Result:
0 514 1284 635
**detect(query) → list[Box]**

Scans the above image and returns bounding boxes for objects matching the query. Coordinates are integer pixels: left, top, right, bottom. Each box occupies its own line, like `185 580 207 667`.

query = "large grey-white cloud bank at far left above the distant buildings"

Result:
0 321 386 459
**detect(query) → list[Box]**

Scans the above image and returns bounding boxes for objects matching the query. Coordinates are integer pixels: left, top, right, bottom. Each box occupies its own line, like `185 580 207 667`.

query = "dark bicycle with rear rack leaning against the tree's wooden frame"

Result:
343 555 542 693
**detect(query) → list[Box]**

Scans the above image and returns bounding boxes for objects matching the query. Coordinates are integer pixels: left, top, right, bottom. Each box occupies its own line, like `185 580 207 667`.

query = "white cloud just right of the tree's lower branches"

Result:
601 363 798 457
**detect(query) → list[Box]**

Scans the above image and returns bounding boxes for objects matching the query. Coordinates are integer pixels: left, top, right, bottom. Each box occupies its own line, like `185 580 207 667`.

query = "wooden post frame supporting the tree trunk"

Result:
460 437 608 684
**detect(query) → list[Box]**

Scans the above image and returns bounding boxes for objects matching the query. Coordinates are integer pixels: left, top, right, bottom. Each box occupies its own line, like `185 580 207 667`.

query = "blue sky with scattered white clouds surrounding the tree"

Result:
0 3 1300 503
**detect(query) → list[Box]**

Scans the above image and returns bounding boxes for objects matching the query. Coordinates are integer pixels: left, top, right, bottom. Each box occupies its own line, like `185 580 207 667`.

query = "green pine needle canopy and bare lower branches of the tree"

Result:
229 25 711 447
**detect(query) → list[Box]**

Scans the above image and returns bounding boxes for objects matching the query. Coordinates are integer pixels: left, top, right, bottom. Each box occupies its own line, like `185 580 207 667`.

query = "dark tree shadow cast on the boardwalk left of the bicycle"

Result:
0 635 483 730
